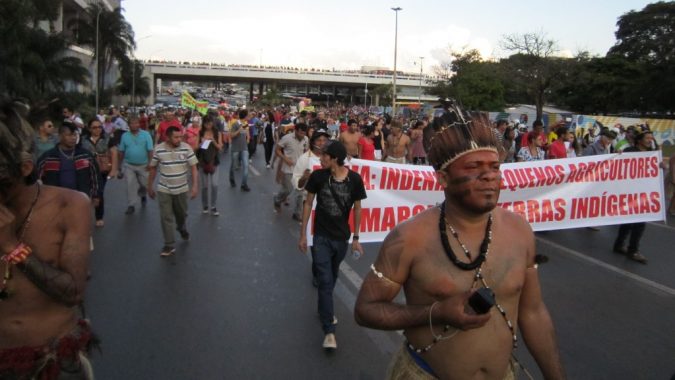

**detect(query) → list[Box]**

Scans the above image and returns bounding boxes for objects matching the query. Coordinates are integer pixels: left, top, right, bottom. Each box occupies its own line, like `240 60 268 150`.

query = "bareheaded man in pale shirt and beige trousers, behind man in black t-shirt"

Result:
274 123 309 221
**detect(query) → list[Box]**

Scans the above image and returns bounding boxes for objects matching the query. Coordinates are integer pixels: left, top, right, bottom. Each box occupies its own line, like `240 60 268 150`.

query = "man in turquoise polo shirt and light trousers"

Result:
117 116 153 215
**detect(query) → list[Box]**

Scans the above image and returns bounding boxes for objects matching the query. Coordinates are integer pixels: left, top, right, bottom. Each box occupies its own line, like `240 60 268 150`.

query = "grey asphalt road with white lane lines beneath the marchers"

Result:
86 152 675 380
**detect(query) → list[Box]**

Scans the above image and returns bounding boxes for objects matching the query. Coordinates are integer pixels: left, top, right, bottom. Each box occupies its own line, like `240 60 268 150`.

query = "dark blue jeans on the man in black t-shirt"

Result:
312 235 348 334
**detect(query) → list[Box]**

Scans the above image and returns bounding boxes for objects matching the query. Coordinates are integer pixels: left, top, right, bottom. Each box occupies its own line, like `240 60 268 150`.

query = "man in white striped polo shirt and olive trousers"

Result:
148 126 199 257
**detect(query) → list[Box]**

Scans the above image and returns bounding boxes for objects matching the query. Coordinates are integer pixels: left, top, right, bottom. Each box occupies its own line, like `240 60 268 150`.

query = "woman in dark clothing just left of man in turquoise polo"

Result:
82 118 114 227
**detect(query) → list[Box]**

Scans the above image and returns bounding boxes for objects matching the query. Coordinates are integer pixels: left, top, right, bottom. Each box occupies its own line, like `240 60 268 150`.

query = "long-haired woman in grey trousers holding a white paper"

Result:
197 116 223 216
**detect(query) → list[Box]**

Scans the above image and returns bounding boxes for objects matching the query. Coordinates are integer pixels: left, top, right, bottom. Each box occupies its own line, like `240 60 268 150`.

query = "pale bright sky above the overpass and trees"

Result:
122 0 649 73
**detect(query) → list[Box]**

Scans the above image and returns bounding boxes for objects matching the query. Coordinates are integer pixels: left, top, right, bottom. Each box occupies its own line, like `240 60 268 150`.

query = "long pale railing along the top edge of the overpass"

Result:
143 61 438 81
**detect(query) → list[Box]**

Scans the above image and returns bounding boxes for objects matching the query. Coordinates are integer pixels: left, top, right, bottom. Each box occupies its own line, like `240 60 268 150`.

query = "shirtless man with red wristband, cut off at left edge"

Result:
0 102 93 379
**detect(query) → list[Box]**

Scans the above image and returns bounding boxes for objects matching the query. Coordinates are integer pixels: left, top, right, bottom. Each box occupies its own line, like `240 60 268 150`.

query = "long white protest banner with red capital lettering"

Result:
308 151 666 242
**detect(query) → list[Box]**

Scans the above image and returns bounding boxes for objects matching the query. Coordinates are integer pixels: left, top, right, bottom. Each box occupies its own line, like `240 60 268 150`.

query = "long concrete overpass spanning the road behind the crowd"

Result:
144 62 438 104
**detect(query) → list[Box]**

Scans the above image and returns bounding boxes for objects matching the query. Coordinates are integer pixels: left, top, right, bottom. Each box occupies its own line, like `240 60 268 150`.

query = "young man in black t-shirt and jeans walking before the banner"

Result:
299 141 366 349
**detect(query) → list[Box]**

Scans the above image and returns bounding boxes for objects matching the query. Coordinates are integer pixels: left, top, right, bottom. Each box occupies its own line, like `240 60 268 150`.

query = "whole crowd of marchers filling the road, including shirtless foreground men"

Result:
0 94 675 379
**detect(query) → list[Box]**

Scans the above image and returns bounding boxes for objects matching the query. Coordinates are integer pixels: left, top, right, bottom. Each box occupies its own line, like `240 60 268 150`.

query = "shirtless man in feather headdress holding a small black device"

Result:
355 114 565 379
